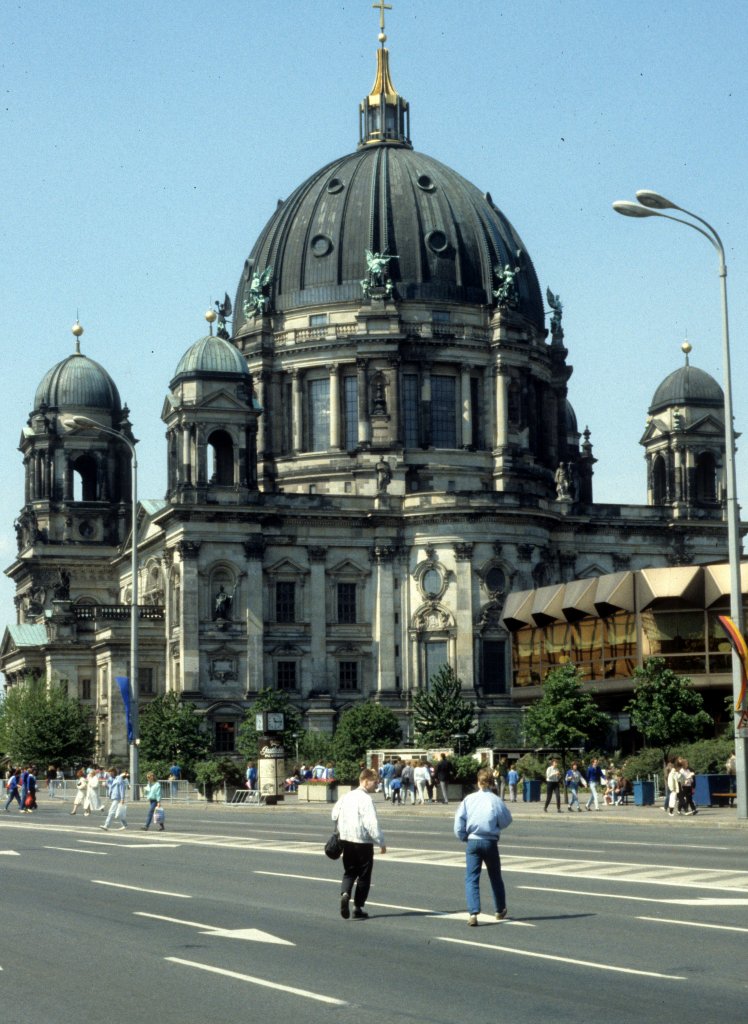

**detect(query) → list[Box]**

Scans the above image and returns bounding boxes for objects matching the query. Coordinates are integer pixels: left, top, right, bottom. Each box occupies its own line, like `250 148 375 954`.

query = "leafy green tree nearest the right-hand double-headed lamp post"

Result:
626 657 712 762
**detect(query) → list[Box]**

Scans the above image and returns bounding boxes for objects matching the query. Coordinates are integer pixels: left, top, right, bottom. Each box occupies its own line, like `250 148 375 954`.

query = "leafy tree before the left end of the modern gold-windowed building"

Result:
525 665 610 767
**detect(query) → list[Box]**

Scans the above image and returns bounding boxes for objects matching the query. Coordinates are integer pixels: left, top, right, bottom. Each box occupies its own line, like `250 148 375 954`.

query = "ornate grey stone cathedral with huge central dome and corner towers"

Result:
0 16 726 757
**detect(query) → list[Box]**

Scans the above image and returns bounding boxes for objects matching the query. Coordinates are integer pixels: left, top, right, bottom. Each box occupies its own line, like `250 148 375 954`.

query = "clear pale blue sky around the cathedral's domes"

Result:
0 0 748 621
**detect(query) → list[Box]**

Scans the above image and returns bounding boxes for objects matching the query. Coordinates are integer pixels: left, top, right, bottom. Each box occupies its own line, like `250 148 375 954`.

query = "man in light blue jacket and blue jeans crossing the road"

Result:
455 768 511 928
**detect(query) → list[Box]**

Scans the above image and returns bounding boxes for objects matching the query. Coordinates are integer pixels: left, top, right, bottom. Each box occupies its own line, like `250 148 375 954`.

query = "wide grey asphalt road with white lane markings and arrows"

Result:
0 801 748 1024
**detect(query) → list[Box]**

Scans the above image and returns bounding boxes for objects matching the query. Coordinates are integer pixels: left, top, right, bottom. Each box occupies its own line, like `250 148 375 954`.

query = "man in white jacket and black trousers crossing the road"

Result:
332 768 387 921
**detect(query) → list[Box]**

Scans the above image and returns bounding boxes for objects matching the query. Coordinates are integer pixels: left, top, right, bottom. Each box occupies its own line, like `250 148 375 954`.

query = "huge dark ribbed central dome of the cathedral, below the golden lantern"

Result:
234 143 544 334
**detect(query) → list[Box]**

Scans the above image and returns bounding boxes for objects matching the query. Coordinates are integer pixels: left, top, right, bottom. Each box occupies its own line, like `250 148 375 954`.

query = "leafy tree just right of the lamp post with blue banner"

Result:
139 693 210 774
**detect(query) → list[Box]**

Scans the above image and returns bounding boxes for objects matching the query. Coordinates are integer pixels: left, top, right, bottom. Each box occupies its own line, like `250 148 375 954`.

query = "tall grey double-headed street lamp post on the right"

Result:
613 189 748 818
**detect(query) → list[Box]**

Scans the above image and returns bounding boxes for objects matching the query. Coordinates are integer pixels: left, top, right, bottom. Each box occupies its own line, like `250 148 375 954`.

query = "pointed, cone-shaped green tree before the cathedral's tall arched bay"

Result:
413 665 477 754
